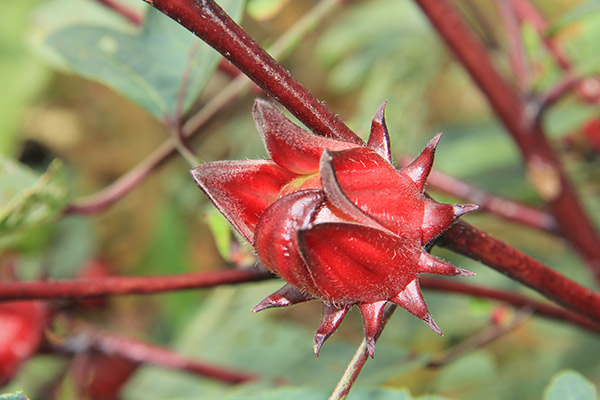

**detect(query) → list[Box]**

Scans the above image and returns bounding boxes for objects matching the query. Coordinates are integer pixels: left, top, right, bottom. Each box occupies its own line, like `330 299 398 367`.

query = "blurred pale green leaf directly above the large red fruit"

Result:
316 0 443 146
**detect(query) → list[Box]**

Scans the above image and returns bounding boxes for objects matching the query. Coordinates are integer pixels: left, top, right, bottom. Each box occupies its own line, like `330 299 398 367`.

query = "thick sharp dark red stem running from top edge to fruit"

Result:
147 0 362 143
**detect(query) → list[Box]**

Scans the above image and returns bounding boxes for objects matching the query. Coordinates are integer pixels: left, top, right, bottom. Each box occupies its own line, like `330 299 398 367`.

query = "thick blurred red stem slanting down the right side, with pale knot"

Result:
415 0 600 282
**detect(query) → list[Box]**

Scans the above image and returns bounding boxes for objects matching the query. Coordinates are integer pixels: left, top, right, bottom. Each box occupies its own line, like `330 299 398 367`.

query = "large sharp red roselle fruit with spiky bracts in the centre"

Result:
192 100 477 357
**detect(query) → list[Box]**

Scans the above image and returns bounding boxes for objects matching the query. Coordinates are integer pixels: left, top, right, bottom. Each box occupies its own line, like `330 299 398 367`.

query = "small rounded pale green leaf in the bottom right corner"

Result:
544 371 598 400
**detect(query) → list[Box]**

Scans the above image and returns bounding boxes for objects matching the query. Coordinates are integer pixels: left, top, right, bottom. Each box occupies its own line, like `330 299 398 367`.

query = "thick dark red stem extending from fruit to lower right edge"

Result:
440 221 600 323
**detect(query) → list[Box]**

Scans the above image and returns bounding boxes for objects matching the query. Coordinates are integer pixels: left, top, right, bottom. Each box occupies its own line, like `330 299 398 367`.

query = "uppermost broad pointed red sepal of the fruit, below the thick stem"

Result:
254 100 358 175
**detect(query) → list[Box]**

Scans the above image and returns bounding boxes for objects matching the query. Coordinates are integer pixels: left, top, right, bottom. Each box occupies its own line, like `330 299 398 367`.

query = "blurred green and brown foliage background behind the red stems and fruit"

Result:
0 0 600 400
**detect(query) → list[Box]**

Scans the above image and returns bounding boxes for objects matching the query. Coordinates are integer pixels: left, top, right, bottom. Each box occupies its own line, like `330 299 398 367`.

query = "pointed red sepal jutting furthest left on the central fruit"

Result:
191 160 297 243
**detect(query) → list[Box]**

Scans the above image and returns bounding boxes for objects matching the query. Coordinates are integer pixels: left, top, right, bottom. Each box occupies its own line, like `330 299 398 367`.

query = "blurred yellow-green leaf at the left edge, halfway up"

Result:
0 157 67 247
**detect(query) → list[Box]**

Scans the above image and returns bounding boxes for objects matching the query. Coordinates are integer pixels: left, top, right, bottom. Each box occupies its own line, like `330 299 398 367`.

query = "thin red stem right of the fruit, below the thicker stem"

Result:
419 277 600 333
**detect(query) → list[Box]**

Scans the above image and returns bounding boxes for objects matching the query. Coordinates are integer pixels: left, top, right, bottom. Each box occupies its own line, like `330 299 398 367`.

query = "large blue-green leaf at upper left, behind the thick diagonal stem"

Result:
46 0 243 119
